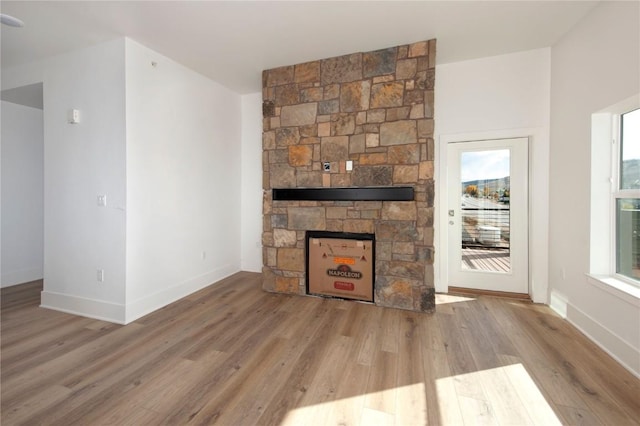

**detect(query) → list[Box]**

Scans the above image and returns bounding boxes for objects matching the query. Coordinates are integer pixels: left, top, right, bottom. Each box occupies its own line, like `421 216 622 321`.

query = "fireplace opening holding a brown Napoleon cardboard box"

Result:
306 231 375 302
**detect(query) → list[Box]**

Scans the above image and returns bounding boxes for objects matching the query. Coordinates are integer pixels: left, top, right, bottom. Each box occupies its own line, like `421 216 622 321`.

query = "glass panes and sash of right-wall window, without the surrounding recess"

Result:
612 109 640 284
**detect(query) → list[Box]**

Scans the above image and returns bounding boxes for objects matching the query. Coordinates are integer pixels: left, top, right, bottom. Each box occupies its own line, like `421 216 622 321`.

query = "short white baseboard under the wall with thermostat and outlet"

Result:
40 291 125 324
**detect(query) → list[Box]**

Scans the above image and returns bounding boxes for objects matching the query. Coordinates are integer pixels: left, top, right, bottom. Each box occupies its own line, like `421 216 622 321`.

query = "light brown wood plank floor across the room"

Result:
1 273 640 426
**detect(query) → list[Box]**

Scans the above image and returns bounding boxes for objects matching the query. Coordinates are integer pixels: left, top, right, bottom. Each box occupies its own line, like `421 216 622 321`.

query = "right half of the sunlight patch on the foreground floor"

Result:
436 364 562 426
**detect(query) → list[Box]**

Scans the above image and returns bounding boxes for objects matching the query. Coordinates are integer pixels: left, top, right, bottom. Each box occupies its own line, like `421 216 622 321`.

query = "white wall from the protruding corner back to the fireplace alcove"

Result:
126 39 242 322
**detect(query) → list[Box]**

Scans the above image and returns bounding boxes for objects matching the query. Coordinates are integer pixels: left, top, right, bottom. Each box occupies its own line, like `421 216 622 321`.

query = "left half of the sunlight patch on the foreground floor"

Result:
281 383 427 426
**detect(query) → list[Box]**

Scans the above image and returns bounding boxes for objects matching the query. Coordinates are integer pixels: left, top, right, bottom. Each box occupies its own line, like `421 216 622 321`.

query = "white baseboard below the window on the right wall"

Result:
550 298 640 378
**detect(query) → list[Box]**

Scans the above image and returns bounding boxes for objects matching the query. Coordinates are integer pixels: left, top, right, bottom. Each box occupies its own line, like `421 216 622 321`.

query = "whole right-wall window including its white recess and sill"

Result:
589 95 640 299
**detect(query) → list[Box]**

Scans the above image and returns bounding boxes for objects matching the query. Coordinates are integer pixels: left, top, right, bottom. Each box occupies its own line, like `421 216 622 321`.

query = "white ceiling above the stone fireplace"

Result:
0 0 598 94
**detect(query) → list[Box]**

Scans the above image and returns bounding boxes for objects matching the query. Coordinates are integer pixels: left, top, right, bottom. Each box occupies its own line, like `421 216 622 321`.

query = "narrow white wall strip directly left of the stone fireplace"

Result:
240 93 262 272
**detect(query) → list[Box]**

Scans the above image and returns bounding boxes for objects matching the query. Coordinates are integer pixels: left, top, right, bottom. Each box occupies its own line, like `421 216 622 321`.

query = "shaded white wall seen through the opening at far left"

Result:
0 101 44 287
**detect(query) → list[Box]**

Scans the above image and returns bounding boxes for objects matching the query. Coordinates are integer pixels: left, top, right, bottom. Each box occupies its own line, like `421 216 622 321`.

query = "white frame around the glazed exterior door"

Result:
434 128 549 304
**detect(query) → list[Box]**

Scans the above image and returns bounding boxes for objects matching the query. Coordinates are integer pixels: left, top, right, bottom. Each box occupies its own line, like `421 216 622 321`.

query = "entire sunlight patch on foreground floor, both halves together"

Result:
281 364 562 426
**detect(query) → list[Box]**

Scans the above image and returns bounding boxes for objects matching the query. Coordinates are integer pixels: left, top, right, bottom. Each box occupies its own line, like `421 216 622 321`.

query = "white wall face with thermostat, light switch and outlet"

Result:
42 39 125 322
